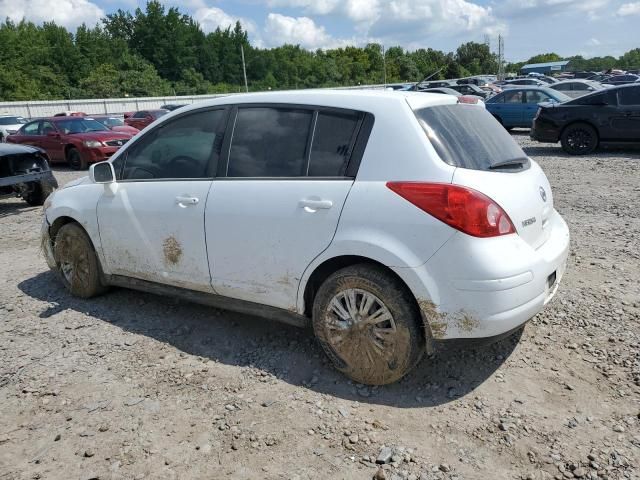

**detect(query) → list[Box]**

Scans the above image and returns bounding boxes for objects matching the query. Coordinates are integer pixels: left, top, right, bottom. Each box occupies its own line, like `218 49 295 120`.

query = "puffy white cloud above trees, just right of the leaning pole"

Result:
264 13 336 49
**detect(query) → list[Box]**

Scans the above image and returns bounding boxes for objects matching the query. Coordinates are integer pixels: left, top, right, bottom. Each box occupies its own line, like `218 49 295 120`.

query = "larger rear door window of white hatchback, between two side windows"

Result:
227 107 313 177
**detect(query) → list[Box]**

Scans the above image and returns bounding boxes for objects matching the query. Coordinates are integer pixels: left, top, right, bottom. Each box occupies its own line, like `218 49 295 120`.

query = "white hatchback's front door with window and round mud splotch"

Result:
98 109 226 292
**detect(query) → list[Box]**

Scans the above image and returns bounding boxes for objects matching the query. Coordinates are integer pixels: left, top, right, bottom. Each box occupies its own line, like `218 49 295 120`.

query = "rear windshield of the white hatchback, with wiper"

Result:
415 104 529 170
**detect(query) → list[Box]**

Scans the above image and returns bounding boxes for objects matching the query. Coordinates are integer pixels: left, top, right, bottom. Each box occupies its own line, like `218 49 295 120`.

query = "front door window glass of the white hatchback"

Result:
122 110 226 180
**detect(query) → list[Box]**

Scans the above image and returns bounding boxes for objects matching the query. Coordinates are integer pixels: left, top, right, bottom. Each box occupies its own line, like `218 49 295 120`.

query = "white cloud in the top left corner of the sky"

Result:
0 0 105 29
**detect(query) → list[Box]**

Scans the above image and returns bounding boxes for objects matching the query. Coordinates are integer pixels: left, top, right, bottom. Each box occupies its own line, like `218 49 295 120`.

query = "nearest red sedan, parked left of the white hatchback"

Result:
7 117 131 170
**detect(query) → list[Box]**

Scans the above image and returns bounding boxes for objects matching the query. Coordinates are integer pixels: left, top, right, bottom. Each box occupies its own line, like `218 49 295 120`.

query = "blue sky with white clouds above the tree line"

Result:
0 0 640 61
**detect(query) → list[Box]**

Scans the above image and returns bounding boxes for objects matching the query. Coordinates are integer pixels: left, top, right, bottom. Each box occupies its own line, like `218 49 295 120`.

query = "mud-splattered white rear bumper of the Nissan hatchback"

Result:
396 211 569 340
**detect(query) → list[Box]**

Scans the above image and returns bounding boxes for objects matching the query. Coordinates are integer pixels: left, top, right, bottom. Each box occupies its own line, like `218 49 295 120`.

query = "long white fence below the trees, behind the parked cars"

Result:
0 85 384 118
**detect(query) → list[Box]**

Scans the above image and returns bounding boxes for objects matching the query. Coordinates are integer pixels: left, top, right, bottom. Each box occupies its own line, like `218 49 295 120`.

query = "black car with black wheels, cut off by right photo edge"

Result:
530 84 640 155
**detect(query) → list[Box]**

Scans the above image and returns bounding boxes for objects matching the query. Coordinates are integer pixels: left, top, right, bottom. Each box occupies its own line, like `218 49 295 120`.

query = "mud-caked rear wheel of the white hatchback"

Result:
313 264 425 385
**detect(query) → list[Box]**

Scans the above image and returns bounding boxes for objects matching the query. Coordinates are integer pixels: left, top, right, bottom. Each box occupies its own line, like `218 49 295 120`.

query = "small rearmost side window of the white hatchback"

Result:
308 112 360 177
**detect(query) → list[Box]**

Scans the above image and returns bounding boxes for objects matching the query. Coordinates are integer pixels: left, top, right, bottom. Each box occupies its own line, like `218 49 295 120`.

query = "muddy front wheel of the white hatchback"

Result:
53 223 107 298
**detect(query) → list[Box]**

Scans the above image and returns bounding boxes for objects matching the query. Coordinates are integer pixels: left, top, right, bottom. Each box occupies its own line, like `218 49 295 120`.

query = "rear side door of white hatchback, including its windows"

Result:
205 105 364 309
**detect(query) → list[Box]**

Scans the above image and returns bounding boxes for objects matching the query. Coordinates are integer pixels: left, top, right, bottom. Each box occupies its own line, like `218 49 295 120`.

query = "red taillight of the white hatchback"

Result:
387 182 516 238
